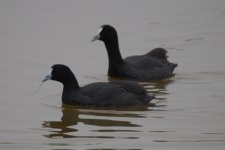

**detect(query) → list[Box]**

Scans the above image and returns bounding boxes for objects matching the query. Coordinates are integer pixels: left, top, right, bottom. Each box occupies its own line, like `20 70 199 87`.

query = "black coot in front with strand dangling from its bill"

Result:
42 64 154 106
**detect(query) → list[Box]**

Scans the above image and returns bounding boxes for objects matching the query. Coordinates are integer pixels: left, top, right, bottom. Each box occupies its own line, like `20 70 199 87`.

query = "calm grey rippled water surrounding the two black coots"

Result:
0 0 225 150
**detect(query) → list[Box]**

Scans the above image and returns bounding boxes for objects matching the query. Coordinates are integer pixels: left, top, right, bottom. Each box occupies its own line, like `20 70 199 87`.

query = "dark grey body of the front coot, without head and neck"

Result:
62 81 151 106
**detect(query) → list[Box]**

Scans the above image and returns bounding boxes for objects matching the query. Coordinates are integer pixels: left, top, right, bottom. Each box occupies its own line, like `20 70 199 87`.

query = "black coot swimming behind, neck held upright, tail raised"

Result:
92 25 177 81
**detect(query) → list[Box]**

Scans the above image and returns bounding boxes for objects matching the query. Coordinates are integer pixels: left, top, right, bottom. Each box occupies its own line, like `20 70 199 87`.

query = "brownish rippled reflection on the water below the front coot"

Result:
42 105 144 138
